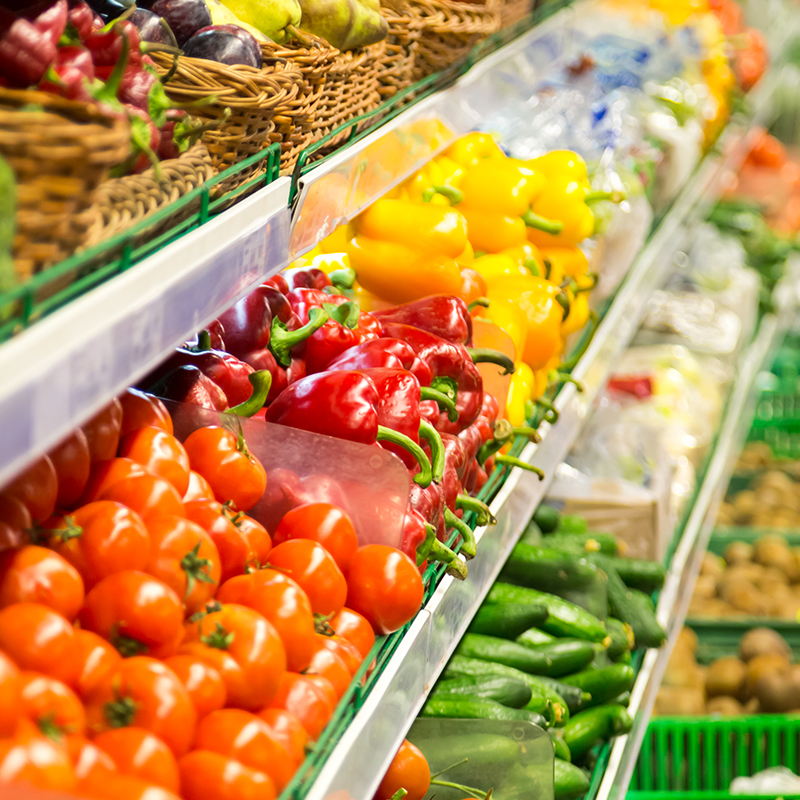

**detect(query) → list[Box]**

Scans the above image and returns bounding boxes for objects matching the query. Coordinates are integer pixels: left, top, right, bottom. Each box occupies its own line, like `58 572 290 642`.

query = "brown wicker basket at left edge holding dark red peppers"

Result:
0 88 130 280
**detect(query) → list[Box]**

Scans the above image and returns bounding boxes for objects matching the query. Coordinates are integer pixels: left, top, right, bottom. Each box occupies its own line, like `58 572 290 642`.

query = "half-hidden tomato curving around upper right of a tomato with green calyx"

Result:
217 569 316 672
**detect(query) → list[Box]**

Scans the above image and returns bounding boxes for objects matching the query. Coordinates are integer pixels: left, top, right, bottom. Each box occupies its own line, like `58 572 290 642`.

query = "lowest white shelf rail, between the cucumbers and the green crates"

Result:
596 283 798 800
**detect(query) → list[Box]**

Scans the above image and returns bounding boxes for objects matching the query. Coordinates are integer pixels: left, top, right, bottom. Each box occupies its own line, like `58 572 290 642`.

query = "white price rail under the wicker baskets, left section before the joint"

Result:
0 178 290 484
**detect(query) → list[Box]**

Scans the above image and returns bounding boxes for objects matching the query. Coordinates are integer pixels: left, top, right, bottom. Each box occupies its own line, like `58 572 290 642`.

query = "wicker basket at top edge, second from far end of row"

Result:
408 0 500 81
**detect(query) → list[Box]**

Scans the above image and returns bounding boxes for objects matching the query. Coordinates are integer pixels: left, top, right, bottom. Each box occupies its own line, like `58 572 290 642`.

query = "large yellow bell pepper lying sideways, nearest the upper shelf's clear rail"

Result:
347 199 467 303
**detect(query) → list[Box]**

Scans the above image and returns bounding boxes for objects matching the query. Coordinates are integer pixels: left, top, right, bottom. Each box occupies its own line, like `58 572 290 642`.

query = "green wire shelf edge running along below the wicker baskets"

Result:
0 0 573 343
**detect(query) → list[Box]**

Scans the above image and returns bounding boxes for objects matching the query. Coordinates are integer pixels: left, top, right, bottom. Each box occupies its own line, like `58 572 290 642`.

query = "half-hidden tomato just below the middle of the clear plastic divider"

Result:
273 503 358 575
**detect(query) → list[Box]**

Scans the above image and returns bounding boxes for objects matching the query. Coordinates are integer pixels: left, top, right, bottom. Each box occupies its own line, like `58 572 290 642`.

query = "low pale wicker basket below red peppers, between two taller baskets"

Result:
87 143 216 246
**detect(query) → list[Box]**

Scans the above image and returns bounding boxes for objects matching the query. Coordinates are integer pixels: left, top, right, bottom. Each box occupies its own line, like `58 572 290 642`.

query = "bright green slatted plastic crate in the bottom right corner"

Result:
628 715 800 800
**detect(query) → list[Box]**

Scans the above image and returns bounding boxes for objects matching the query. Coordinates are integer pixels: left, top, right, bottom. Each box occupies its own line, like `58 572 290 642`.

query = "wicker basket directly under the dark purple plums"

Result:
153 53 303 180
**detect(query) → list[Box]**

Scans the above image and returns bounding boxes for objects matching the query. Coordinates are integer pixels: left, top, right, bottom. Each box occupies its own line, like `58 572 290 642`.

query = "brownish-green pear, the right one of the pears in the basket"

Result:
300 0 389 50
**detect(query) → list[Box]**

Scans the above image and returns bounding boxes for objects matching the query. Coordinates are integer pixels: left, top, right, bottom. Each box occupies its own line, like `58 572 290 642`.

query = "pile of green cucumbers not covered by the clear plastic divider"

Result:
422 506 666 800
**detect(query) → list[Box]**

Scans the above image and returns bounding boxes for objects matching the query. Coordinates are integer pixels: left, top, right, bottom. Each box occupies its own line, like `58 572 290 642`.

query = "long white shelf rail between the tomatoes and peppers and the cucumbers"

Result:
296 81 776 800
